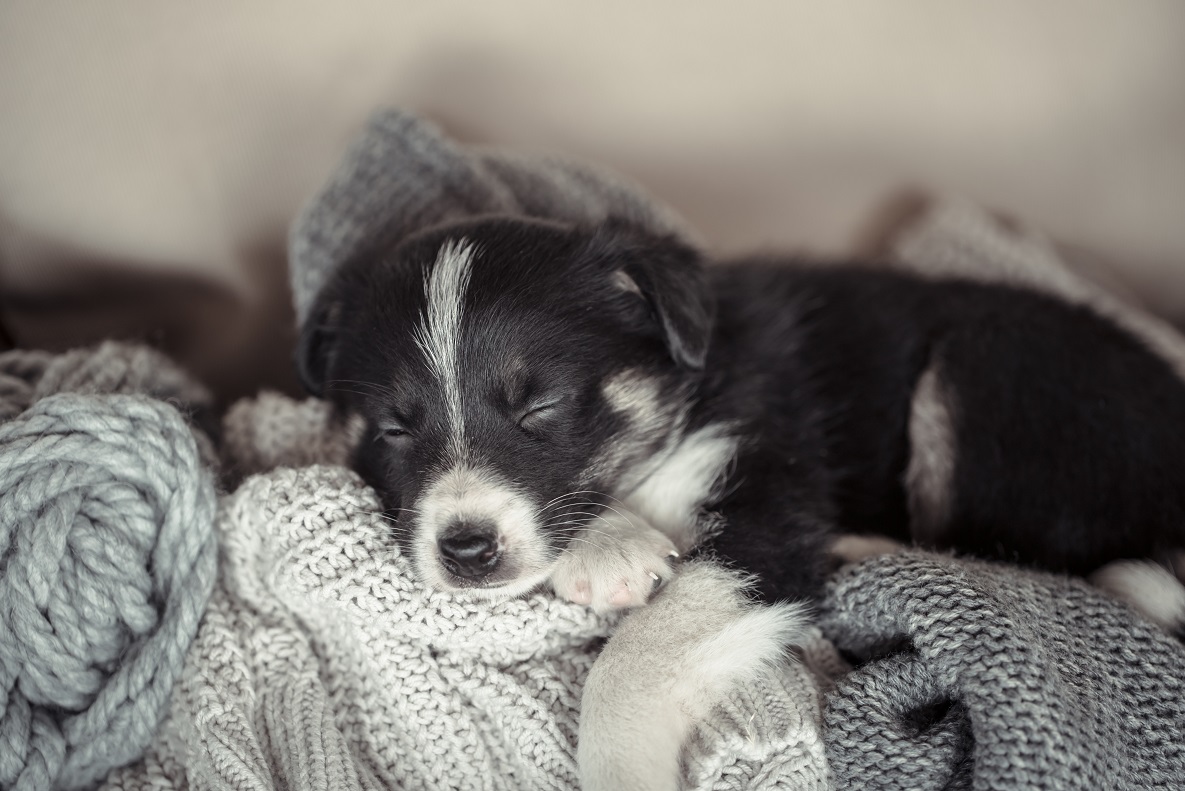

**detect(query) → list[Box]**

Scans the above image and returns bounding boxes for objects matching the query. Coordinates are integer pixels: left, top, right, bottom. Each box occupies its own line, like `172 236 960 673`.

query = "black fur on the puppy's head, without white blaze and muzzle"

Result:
297 218 710 575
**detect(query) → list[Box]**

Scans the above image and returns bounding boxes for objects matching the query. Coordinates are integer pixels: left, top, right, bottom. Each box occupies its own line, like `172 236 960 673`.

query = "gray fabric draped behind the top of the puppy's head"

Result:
288 110 691 323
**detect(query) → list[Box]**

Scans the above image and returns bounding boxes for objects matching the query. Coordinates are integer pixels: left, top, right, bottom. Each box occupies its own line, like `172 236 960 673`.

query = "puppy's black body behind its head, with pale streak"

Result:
691 261 1185 598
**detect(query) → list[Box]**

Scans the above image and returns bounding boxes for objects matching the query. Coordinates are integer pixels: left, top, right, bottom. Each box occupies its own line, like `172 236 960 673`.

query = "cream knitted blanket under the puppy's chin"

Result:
104 394 840 790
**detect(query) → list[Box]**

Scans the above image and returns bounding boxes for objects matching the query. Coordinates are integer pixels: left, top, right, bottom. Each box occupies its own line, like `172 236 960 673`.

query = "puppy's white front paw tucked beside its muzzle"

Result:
551 512 679 612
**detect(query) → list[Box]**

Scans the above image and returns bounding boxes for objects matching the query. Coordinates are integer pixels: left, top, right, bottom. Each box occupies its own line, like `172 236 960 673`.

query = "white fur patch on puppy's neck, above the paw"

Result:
623 424 737 552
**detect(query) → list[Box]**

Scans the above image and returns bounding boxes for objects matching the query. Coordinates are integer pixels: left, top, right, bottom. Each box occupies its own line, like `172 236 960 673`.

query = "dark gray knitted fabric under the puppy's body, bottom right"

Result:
820 552 1185 791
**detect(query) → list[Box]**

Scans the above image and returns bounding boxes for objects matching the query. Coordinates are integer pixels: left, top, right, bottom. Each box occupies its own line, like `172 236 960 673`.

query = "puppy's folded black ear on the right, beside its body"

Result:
613 229 715 369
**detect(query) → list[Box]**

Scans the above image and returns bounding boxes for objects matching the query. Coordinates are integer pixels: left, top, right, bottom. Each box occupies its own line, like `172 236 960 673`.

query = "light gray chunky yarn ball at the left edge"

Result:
0 345 216 791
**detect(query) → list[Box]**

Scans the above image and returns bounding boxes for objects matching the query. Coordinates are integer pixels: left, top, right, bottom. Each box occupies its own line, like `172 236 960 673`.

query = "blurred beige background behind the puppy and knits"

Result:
0 0 1185 397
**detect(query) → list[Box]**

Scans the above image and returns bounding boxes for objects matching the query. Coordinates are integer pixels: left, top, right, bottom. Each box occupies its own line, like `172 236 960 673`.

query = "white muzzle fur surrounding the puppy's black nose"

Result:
412 463 551 598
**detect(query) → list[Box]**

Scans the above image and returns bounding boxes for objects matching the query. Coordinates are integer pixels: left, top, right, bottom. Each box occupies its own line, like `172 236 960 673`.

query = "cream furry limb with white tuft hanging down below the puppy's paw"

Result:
577 561 809 791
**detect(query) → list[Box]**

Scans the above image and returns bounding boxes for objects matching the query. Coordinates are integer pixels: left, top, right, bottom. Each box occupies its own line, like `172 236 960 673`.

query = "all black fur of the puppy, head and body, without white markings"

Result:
299 218 1185 599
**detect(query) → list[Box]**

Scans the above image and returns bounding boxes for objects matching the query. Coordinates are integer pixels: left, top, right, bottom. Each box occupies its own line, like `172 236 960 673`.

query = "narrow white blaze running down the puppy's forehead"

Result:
416 239 475 458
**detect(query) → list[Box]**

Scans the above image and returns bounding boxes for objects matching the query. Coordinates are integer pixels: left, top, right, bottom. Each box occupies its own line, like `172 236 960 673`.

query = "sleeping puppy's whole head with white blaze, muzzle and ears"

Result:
297 218 711 596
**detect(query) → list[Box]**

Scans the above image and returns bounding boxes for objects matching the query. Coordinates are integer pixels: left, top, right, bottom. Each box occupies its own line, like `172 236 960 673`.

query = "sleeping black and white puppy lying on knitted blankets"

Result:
297 217 1185 625
